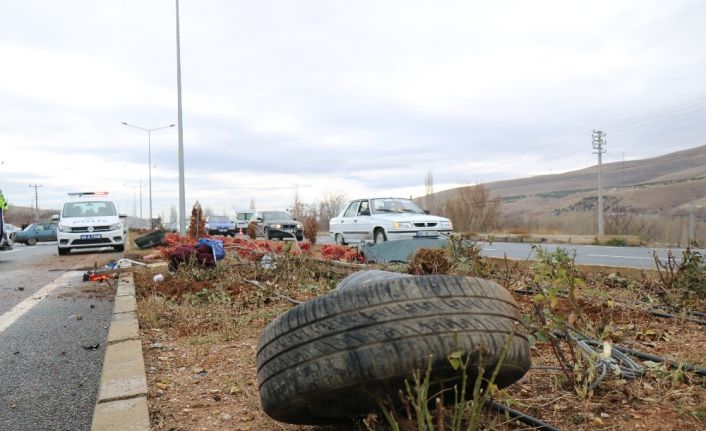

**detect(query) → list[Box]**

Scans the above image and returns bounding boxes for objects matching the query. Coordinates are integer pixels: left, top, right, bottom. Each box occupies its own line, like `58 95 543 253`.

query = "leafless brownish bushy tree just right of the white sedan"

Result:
446 184 501 232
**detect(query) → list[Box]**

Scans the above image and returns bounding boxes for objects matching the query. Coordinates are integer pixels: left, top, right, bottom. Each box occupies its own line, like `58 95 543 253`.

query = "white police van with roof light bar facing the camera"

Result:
52 192 127 255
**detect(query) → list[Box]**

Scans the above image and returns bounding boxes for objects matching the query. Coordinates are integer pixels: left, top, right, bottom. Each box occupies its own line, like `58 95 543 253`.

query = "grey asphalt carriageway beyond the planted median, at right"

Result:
316 235 706 269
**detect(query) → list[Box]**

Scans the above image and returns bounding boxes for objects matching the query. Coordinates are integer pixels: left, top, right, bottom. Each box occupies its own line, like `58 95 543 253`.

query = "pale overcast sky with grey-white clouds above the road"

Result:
0 0 706 221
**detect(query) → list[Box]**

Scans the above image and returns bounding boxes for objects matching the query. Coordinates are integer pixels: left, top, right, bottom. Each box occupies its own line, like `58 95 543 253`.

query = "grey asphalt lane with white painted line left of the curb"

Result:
0 243 120 431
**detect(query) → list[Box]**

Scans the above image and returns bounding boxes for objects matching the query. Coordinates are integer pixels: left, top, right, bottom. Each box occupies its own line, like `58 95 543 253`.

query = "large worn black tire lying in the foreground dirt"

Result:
257 275 530 424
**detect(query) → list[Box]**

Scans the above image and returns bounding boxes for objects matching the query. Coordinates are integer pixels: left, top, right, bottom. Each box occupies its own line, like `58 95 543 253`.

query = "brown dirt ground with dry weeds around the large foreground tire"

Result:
129 245 706 431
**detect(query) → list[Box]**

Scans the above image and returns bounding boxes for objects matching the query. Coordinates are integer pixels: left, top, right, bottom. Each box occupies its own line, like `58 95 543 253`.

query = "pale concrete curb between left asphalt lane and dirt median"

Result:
91 272 150 431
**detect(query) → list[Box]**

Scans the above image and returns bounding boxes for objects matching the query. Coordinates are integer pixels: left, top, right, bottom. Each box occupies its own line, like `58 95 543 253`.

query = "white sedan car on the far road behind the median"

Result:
331 198 453 245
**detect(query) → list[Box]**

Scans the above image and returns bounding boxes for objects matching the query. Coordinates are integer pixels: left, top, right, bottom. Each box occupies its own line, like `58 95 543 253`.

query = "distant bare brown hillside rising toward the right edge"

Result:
428 145 706 215
